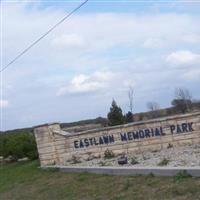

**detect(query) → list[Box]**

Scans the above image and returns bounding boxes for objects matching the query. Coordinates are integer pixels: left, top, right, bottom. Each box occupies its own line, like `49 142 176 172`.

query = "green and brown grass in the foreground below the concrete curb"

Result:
0 161 200 200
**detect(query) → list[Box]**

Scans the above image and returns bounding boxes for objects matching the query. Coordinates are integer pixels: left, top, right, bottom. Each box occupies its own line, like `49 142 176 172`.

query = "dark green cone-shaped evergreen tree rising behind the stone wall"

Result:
107 99 124 126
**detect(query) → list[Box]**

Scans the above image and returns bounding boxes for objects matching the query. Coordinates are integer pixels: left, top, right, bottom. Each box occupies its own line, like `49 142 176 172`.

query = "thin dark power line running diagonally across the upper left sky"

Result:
0 0 89 72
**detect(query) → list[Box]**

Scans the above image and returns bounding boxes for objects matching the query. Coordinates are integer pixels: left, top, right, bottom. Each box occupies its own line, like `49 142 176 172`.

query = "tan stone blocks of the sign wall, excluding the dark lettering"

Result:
34 112 200 166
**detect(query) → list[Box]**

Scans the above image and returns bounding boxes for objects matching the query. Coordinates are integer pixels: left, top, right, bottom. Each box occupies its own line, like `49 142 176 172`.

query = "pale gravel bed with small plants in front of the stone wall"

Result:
66 144 200 167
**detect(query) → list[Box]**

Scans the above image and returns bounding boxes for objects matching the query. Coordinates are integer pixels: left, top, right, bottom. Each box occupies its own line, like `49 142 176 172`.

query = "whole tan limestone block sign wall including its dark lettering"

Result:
34 112 200 166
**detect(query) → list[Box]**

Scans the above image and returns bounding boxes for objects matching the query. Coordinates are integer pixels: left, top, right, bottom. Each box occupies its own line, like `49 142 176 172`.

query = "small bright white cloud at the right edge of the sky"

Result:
167 50 200 65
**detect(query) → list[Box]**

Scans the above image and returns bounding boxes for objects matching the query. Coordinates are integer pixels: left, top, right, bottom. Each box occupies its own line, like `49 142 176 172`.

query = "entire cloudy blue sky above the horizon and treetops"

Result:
0 0 200 130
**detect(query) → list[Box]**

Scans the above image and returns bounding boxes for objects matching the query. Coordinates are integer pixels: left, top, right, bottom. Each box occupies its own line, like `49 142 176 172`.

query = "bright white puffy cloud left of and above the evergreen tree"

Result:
57 71 114 96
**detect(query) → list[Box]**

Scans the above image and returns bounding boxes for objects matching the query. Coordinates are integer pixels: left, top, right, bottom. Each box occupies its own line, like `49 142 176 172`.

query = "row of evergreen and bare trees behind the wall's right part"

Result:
107 86 200 126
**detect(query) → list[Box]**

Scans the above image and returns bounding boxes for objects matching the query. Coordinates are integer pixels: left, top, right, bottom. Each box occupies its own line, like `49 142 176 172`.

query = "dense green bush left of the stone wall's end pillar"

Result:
0 132 38 160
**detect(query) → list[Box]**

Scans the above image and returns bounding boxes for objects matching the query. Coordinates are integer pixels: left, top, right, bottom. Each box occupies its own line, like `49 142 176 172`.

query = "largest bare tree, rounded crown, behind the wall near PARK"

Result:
172 88 192 113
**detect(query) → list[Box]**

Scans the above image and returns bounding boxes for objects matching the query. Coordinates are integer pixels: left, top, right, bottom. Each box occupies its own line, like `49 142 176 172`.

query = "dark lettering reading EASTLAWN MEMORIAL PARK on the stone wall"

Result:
74 122 194 149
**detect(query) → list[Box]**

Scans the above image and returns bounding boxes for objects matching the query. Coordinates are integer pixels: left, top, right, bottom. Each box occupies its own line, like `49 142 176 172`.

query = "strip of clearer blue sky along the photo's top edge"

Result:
32 0 200 14
